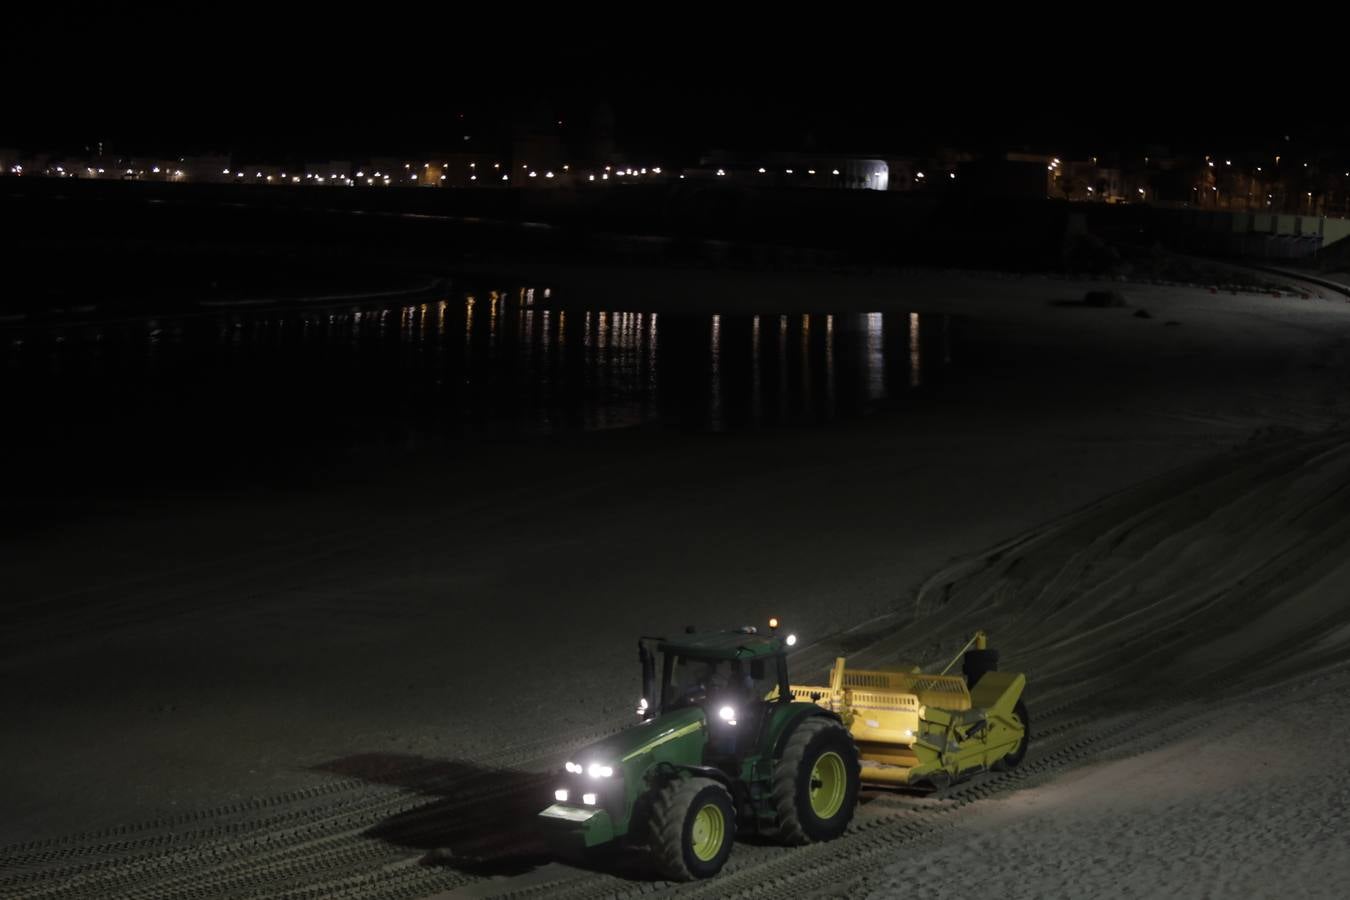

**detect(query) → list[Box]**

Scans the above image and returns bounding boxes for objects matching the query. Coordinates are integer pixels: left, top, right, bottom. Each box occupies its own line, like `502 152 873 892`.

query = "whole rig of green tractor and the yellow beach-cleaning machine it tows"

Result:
539 619 1031 881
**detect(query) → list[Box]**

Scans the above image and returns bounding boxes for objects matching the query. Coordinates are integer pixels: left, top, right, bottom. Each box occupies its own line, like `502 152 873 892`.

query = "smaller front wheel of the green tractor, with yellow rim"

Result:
649 779 736 881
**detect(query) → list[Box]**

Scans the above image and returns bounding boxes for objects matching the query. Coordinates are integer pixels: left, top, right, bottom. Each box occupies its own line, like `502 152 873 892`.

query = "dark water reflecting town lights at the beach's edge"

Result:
0 289 952 496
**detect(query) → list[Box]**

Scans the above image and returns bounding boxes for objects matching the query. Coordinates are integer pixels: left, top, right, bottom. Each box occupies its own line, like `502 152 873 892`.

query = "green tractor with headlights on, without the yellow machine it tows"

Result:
540 627 860 881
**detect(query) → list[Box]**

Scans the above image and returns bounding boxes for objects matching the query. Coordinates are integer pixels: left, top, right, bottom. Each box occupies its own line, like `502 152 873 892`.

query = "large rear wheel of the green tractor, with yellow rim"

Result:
774 716 861 845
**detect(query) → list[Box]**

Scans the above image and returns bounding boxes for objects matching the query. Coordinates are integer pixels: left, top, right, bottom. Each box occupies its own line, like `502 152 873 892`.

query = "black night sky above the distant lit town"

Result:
0 12 1350 158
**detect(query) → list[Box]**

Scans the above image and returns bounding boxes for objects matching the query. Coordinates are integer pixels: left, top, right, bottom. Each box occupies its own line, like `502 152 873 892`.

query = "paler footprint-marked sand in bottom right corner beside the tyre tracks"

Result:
851 673 1350 897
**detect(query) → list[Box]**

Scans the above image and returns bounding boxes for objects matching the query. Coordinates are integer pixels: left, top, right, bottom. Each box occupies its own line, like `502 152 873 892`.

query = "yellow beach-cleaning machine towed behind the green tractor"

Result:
791 631 1031 788
